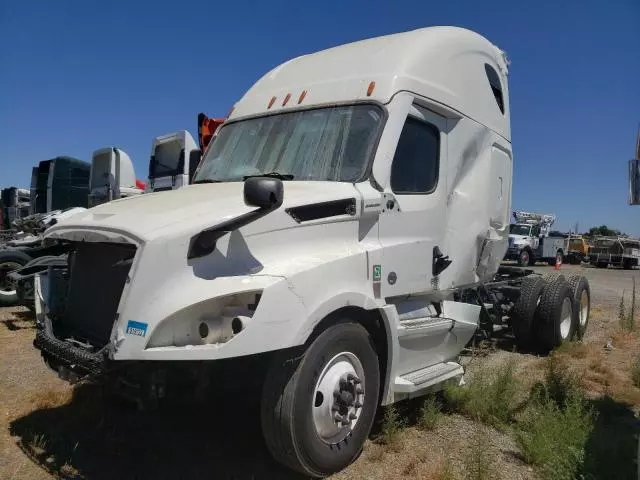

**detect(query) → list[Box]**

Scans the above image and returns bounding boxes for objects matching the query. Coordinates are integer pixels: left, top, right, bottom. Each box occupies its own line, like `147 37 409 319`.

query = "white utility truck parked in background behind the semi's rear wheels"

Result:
504 211 568 267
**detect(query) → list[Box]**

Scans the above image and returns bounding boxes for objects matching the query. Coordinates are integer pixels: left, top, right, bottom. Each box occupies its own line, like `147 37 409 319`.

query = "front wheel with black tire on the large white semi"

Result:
261 323 380 477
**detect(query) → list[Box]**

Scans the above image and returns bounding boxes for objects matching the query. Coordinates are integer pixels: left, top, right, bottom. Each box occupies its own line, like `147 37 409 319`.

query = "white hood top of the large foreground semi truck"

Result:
45 181 360 242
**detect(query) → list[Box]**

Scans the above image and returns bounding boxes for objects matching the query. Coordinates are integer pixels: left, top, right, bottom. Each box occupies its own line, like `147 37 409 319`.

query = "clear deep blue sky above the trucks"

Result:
0 0 640 236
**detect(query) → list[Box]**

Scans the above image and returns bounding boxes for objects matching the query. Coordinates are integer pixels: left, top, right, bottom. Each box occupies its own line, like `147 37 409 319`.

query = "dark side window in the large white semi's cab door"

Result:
391 117 440 194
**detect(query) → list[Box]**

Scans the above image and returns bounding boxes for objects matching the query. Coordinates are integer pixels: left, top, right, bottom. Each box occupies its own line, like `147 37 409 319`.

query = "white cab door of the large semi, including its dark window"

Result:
374 103 447 298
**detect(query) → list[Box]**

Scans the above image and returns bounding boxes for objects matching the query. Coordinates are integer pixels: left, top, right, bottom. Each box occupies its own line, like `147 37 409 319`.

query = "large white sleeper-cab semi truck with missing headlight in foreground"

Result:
34 27 589 477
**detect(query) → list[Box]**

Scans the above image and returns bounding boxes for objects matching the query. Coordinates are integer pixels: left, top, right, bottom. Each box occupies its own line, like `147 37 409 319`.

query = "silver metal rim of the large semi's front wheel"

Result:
311 352 365 443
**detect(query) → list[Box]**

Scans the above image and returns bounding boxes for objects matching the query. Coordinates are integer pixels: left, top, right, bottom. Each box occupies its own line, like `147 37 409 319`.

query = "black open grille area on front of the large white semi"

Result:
54 243 136 348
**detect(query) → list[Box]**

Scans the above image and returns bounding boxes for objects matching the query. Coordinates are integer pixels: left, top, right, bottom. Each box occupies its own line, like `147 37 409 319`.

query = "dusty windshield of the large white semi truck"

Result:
194 105 383 182
